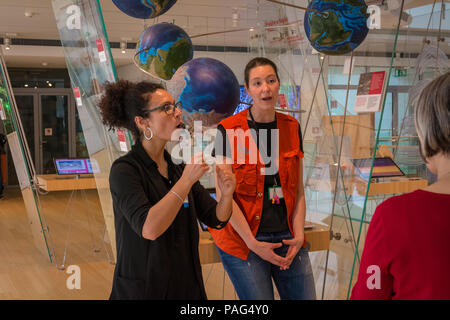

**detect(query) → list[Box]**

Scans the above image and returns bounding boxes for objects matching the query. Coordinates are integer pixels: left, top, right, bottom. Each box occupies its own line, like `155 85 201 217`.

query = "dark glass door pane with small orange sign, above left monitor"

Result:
41 95 69 174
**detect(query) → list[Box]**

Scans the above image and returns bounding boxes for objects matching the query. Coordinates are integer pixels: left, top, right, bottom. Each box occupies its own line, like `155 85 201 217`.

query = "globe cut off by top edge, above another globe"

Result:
113 0 177 19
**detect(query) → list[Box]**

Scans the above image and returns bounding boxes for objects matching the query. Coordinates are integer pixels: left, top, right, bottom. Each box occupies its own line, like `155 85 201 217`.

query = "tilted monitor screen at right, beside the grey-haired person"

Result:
352 157 405 180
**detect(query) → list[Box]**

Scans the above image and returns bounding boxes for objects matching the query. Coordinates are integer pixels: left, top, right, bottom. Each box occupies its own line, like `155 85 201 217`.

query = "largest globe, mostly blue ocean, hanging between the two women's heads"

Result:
167 58 240 129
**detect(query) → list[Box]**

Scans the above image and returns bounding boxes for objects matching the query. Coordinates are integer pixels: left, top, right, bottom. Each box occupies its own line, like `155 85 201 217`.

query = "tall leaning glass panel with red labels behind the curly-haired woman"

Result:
52 0 123 262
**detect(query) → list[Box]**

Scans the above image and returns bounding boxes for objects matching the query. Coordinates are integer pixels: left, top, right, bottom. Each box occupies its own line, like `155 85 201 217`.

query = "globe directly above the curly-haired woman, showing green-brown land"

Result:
135 22 193 80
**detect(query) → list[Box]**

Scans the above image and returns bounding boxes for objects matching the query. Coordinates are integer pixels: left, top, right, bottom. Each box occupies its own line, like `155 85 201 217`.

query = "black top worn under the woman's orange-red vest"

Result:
213 120 303 233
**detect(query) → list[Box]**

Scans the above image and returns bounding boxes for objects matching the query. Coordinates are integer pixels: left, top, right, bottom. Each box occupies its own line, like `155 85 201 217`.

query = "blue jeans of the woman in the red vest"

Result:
217 231 316 300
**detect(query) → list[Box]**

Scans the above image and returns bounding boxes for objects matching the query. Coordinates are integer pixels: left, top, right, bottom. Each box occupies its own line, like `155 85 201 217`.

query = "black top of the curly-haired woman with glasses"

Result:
109 143 226 299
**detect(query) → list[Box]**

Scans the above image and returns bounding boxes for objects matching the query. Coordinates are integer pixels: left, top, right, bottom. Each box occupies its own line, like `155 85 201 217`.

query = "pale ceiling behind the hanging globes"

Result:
0 0 450 68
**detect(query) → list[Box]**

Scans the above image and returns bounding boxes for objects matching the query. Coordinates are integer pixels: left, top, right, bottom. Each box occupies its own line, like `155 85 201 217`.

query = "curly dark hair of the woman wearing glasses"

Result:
98 80 164 141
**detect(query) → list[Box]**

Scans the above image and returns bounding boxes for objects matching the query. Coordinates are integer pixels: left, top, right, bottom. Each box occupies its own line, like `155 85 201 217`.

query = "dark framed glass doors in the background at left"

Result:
8 88 80 178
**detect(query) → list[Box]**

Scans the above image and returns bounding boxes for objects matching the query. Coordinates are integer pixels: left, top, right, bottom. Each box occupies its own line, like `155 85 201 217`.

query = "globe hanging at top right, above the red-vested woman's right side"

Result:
304 0 369 55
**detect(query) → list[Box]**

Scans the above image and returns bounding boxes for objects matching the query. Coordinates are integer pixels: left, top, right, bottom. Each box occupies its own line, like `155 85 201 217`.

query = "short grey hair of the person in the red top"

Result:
415 72 450 158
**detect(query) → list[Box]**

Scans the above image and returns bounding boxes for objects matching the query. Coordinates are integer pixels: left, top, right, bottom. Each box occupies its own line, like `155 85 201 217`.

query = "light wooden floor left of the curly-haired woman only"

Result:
0 189 114 299
